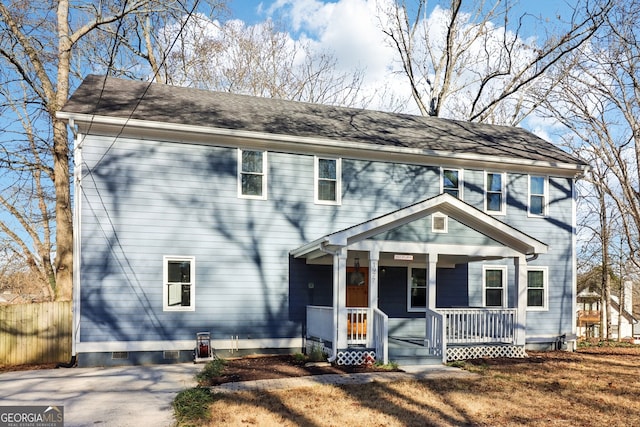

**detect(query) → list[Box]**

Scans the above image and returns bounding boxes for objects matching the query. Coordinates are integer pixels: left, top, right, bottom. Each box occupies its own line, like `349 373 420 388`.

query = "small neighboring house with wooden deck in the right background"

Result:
576 282 638 339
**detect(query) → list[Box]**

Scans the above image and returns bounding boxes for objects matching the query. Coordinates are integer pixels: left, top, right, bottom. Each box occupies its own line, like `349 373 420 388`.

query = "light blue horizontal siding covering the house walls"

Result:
76 136 573 352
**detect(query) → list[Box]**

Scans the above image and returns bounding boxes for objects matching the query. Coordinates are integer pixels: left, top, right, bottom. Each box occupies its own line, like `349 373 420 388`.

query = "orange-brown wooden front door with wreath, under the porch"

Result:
347 267 369 340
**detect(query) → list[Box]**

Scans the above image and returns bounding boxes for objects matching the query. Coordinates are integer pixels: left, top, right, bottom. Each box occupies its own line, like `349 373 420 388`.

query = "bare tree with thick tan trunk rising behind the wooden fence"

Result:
0 0 225 300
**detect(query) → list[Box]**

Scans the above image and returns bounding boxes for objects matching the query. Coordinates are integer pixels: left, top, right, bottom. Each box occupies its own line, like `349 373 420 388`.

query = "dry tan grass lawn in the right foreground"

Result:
204 348 640 427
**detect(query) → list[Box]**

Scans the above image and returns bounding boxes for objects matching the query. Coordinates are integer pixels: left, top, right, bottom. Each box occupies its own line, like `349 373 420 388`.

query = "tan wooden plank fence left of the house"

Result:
0 301 72 365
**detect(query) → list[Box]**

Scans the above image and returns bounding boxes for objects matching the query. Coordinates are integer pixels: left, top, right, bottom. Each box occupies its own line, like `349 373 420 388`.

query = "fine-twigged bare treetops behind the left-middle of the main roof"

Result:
165 19 366 106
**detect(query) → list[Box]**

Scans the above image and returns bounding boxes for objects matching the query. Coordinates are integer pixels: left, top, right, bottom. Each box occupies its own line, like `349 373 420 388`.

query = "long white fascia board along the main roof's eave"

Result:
56 111 586 178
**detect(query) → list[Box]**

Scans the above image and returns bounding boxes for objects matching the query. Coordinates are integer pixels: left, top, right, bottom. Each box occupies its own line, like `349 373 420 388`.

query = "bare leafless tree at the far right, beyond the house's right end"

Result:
541 0 640 338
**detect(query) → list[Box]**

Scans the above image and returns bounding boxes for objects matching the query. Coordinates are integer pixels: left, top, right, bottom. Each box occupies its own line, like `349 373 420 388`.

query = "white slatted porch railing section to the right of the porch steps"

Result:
438 308 518 344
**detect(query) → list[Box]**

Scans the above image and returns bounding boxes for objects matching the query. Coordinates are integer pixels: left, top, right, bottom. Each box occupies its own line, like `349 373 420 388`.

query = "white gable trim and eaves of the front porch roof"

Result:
290 194 548 259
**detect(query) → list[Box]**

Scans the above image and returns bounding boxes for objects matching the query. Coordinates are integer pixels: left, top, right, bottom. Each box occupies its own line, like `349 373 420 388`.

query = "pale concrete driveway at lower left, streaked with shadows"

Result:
0 363 202 427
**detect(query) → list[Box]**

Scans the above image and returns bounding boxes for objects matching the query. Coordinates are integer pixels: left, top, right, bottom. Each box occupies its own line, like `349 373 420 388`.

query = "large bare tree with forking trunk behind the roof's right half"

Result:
379 0 610 125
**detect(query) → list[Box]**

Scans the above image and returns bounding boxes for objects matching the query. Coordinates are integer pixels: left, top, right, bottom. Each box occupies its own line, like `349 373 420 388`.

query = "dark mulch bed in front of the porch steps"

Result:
203 355 400 386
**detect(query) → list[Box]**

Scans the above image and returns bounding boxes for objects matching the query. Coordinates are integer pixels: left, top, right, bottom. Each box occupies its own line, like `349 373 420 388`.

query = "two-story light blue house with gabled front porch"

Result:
58 75 586 366
